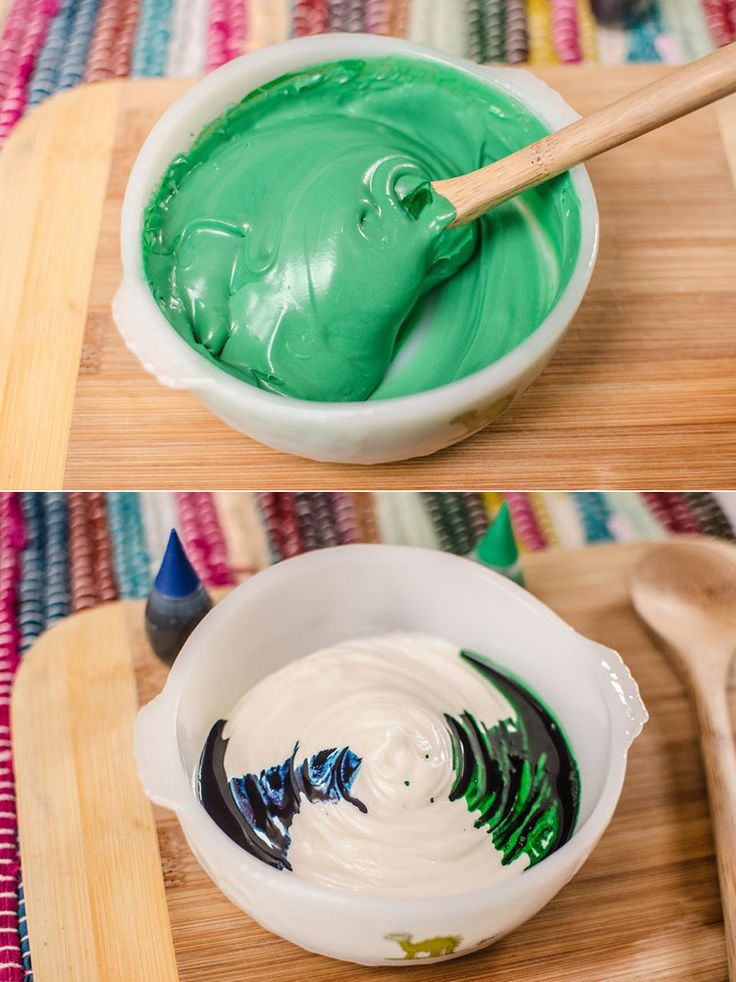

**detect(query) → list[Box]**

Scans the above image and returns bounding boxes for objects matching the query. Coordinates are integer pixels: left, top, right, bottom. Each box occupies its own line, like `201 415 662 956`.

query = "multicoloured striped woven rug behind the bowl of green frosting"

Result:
0 0 736 142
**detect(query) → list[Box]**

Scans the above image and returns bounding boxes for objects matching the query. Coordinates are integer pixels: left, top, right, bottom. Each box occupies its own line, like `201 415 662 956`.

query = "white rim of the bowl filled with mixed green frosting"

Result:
113 33 599 424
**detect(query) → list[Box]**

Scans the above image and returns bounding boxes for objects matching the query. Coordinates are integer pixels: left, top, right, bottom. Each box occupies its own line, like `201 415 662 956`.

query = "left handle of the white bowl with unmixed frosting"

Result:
133 693 187 811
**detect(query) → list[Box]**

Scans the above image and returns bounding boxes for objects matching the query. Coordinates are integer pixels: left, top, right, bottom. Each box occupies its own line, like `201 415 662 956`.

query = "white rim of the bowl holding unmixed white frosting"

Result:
134 543 648 916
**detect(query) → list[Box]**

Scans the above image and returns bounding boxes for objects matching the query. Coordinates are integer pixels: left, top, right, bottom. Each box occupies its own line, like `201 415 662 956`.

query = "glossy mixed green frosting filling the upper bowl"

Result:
143 57 580 401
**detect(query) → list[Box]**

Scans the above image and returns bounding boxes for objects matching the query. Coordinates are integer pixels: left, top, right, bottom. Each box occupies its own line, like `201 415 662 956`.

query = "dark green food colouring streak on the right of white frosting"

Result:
445 651 580 866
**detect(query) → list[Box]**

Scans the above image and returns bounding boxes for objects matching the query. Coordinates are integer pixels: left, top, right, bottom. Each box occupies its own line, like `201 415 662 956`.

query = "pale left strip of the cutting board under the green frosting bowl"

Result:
0 86 117 488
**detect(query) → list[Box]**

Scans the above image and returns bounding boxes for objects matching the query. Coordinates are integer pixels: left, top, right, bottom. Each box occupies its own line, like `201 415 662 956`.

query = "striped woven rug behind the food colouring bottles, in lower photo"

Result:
0 491 736 982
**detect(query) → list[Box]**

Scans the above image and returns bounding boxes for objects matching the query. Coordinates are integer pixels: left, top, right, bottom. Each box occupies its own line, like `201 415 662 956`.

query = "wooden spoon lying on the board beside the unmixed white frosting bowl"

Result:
631 542 736 980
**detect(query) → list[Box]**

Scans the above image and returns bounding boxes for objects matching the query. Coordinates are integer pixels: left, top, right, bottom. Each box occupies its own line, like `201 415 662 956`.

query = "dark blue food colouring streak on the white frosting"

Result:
197 720 367 870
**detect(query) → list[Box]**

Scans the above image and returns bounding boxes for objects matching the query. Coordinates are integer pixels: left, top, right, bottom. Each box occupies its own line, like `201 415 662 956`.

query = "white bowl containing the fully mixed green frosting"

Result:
113 34 598 464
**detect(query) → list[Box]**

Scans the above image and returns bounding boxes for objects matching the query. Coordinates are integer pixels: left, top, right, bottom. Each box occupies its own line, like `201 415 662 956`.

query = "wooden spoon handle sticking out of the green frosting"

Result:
432 43 736 225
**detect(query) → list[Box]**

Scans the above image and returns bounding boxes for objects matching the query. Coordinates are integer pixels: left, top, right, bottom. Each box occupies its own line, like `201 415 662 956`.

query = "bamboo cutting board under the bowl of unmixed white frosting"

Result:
13 544 736 982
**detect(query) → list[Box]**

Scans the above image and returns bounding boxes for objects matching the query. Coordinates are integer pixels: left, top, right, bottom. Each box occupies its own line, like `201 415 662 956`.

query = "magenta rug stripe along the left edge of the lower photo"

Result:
0 500 25 982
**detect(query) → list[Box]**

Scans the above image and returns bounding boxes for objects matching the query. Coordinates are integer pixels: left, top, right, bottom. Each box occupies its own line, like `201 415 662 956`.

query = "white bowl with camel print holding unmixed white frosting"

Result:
135 545 647 965
